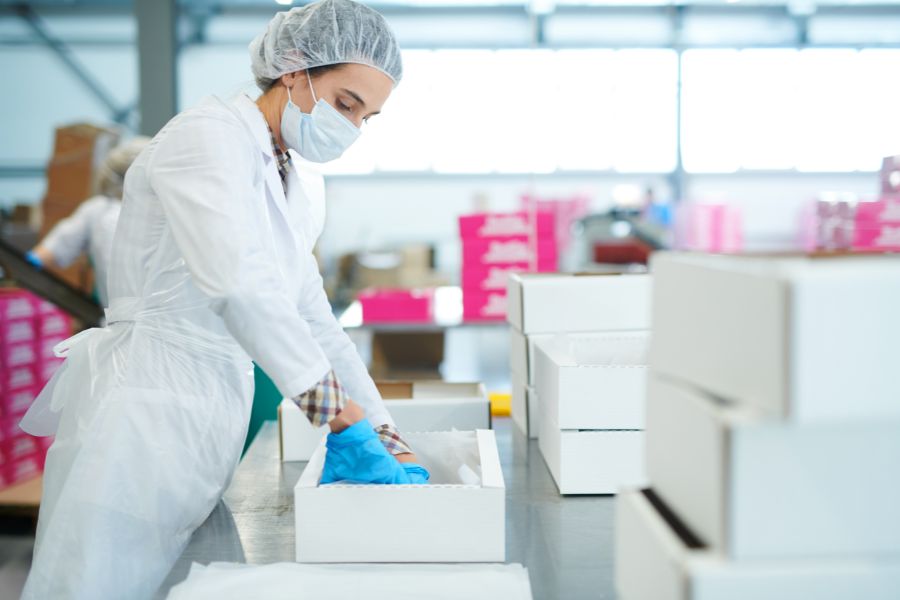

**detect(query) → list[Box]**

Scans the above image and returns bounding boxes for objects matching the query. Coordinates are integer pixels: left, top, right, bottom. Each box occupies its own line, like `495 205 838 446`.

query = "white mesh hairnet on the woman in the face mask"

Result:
250 0 403 90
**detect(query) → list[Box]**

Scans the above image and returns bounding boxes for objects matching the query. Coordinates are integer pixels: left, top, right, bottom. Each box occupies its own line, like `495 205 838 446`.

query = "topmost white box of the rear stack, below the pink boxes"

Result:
506 273 651 335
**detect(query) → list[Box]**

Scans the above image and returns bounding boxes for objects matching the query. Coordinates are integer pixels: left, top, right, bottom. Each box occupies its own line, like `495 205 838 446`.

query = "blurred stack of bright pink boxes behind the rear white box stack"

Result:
459 211 559 321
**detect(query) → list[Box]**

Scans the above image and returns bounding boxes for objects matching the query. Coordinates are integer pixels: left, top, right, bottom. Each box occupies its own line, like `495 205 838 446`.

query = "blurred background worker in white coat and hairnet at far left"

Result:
28 136 150 306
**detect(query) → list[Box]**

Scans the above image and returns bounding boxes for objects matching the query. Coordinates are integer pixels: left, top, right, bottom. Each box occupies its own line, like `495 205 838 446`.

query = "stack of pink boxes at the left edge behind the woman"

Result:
0 288 72 489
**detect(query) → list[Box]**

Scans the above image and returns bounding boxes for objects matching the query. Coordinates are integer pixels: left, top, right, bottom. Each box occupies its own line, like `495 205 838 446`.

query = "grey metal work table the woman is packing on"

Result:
158 418 615 600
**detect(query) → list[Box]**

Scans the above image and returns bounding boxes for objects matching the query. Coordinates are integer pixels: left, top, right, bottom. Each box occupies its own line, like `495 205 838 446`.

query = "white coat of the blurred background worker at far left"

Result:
41 196 122 306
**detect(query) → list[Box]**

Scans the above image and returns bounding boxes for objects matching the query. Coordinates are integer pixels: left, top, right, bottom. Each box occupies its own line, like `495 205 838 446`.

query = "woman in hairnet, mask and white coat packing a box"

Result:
22 0 427 600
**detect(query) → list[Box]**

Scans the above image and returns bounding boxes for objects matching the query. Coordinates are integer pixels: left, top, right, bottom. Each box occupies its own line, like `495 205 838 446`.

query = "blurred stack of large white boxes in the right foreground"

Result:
616 254 900 600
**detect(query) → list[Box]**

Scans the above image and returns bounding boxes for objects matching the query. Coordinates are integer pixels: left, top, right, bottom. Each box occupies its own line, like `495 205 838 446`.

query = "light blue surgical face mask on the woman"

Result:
281 72 360 163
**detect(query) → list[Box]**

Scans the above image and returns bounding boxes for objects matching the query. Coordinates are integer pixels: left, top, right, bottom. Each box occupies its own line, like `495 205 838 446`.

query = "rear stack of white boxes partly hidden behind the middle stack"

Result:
507 273 651 439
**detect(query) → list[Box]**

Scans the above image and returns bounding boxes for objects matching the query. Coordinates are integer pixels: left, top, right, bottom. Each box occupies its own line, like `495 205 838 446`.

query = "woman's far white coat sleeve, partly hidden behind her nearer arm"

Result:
298 253 394 427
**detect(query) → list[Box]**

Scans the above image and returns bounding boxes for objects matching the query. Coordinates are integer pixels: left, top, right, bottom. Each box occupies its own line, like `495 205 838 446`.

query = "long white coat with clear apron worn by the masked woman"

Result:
23 96 393 599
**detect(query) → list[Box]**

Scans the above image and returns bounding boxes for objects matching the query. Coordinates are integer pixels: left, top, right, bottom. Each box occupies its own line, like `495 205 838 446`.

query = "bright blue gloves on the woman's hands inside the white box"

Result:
321 420 429 484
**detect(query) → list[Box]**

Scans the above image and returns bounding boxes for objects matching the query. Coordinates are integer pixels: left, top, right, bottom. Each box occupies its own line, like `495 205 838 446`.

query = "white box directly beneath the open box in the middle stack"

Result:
538 402 646 495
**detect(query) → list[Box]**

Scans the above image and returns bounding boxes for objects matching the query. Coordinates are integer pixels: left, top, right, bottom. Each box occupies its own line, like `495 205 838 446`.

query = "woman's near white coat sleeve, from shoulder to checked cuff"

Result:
148 115 329 398
